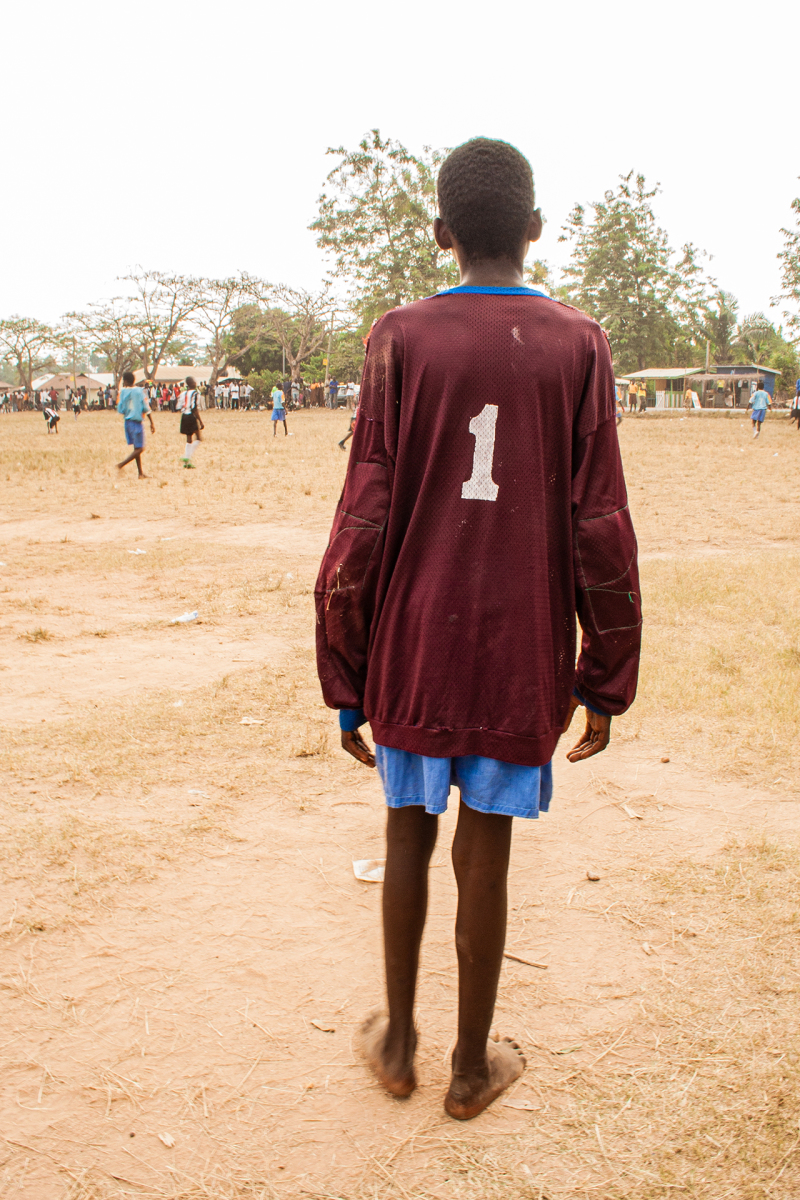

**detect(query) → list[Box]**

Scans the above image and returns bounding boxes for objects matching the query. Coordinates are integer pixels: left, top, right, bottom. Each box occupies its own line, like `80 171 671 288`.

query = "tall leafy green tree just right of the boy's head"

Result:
559 172 709 371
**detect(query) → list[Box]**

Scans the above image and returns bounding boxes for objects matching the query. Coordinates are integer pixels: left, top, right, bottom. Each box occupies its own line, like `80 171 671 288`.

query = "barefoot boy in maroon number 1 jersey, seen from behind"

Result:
317 138 640 1120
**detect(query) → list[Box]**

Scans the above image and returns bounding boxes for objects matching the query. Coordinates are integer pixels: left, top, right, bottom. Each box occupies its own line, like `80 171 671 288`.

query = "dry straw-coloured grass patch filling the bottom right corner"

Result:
429 840 800 1200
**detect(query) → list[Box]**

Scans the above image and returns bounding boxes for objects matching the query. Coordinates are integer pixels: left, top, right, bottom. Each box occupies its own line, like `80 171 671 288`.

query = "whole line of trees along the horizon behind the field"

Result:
0 130 800 390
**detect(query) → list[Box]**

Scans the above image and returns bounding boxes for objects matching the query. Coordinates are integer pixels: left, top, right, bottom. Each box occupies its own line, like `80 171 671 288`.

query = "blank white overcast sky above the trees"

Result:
0 0 800 319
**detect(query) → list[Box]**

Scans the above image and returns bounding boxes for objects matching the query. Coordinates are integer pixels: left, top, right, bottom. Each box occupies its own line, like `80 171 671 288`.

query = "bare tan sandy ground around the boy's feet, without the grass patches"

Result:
0 408 799 1200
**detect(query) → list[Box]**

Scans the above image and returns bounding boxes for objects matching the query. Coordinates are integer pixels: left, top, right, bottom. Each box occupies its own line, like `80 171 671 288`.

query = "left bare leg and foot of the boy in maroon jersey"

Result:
361 804 439 1096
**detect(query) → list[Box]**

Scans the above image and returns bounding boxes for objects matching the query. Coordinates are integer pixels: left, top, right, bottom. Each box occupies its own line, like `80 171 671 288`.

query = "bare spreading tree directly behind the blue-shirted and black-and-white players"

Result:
121 268 203 378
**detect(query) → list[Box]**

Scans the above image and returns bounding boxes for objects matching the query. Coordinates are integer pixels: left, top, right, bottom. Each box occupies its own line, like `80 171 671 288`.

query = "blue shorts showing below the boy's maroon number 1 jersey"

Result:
375 745 553 817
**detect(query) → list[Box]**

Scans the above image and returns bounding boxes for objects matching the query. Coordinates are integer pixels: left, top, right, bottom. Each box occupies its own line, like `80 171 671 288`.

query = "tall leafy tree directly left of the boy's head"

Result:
311 130 458 330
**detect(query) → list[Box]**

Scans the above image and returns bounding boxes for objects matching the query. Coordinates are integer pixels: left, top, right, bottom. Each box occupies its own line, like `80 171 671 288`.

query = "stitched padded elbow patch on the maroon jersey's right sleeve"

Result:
575 505 642 634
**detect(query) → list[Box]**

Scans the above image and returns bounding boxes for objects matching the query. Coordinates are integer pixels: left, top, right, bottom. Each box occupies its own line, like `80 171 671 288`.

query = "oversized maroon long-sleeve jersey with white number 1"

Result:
315 289 642 766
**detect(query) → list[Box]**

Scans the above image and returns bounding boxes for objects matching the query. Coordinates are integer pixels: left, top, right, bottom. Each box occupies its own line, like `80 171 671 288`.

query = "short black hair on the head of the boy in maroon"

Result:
437 138 534 260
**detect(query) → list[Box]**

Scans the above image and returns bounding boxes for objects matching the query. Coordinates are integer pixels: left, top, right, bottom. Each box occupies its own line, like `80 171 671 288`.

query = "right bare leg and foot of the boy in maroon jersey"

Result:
445 800 525 1121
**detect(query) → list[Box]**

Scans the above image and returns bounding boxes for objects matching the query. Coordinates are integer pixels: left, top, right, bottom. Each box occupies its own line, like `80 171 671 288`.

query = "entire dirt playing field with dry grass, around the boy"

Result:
0 412 800 1200
